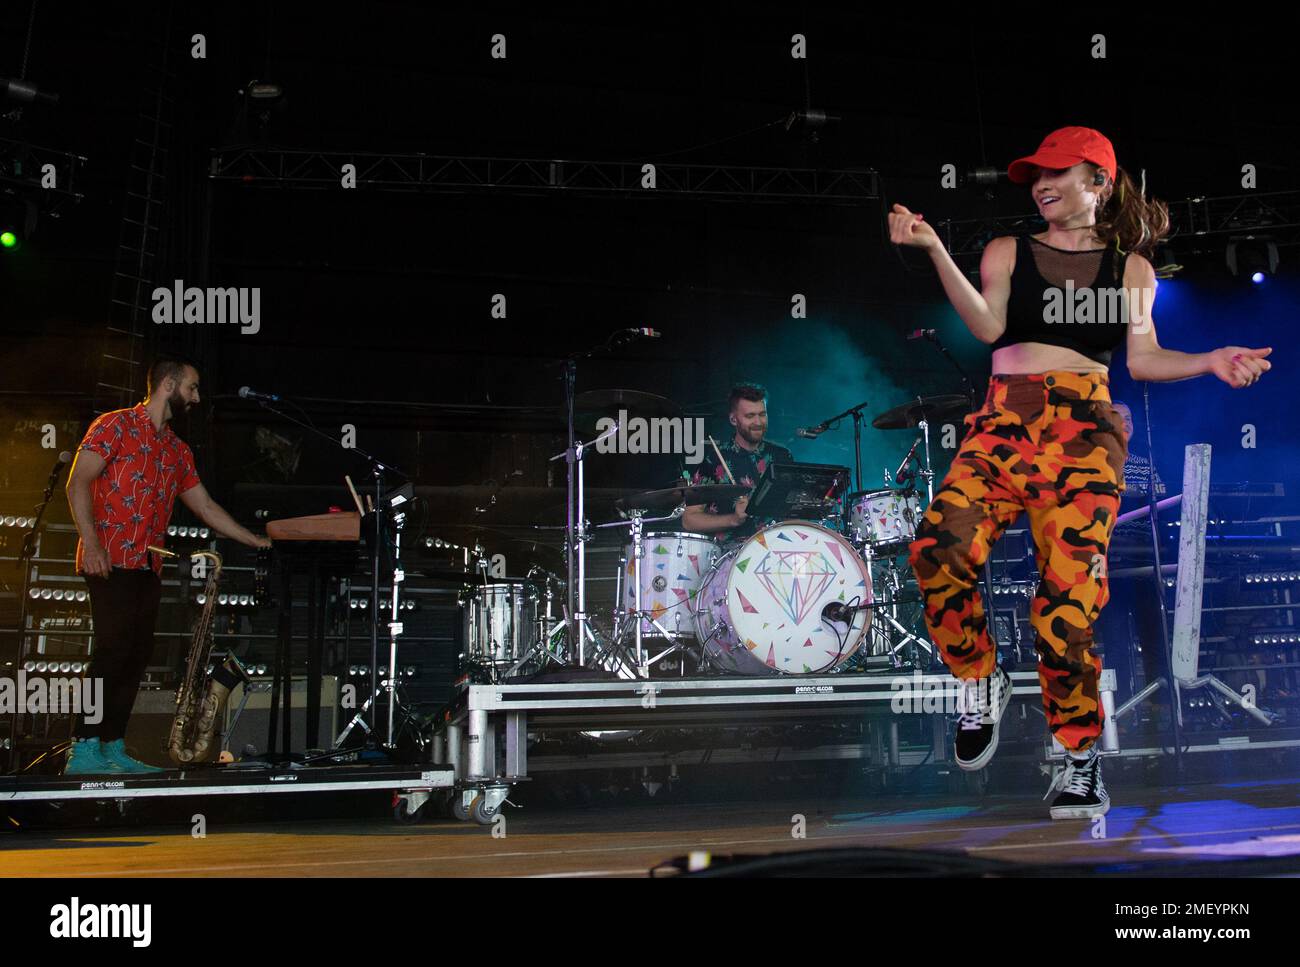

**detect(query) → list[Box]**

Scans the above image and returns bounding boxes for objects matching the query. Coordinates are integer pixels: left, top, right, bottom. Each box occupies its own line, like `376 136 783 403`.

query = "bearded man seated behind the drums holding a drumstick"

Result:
681 382 794 542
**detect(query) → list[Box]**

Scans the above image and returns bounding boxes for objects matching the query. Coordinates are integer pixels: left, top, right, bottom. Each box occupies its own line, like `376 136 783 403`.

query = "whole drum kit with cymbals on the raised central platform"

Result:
449 390 969 682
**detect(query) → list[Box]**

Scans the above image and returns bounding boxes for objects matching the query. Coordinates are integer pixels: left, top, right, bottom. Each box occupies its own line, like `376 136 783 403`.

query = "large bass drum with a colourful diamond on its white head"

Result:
696 520 871 675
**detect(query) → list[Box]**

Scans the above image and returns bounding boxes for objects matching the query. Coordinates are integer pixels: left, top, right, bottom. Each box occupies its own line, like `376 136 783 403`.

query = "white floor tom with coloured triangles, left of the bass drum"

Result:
623 530 722 638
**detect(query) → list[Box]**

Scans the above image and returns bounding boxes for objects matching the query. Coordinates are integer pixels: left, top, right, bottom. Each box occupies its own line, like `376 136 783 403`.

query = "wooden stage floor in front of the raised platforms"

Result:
0 780 1300 877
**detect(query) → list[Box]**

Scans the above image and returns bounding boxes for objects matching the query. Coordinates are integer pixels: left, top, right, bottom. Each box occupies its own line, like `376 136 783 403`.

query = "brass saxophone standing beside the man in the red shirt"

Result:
168 551 248 766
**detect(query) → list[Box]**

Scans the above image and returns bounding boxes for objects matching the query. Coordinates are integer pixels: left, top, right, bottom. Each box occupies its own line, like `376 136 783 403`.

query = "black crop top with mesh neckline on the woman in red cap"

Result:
993 235 1128 367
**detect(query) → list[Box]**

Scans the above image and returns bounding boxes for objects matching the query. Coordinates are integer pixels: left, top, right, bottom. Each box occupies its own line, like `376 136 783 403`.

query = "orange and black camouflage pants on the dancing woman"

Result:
909 370 1128 751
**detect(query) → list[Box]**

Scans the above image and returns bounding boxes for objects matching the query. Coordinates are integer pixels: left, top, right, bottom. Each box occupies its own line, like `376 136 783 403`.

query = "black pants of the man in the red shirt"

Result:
77 568 163 742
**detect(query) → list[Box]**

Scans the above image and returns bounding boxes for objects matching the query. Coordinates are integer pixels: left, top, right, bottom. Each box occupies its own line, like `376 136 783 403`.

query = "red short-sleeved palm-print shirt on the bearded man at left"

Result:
77 403 199 573
